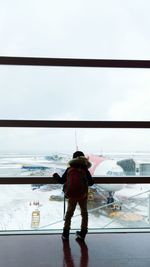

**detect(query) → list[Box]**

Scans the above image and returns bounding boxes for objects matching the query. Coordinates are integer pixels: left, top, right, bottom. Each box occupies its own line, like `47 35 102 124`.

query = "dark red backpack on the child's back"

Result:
63 167 88 199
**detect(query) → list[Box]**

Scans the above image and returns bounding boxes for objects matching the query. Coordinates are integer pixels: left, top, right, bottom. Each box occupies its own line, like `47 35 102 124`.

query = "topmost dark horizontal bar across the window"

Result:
0 56 150 68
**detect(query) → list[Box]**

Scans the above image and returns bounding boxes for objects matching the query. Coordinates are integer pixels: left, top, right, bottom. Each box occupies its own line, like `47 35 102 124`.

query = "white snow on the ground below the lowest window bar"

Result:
0 185 147 230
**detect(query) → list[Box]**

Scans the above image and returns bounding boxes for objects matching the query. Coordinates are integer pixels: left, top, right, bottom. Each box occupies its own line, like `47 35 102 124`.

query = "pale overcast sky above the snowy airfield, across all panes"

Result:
0 0 150 152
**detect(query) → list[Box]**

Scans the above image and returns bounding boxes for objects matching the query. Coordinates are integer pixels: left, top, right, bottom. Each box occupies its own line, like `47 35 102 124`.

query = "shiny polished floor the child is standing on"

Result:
0 233 150 267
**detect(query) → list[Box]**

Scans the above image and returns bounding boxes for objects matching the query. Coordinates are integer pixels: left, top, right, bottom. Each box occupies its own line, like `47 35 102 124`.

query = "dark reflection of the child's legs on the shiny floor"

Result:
62 239 89 267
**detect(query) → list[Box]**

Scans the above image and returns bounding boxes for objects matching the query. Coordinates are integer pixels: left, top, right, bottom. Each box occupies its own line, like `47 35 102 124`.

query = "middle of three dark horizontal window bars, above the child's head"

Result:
0 120 150 129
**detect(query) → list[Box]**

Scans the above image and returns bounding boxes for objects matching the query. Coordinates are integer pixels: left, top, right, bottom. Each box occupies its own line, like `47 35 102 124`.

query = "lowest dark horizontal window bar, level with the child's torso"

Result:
0 176 150 184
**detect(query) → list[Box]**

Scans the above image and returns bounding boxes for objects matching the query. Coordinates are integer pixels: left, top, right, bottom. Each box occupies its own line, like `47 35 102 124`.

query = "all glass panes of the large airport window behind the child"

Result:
0 0 150 231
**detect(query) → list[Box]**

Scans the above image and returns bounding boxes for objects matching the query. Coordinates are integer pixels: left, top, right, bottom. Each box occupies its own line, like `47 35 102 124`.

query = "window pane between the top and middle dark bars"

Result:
0 65 150 121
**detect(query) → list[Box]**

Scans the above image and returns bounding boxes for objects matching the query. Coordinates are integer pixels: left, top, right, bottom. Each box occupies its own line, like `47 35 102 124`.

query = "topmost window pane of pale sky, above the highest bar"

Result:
0 0 150 59
